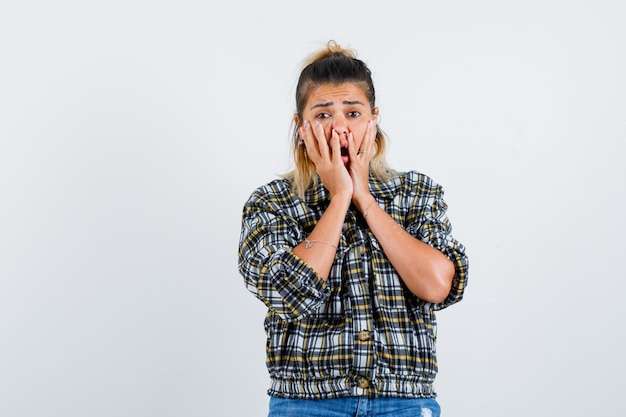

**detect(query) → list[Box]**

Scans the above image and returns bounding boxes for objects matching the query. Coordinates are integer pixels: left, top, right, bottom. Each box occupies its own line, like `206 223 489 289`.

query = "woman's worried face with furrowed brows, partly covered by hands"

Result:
302 83 378 162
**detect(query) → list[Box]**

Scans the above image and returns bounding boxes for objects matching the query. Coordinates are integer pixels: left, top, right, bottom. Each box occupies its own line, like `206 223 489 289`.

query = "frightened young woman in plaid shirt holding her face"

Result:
239 41 468 417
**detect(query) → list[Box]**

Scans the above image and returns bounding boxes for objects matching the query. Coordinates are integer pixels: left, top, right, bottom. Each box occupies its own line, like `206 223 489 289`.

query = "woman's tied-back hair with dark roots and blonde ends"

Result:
283 40 396 198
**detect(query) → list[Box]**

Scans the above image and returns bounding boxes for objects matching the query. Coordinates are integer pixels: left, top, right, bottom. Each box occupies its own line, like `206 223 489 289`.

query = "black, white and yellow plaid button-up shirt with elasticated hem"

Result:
239 171 468 399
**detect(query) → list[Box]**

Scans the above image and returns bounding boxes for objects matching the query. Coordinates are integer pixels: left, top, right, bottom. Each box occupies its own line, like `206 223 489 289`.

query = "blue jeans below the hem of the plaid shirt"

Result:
268 397 441 417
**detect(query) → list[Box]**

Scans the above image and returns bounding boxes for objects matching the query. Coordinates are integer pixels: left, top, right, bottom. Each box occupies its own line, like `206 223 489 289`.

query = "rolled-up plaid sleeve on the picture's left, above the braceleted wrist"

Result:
238 190 330 321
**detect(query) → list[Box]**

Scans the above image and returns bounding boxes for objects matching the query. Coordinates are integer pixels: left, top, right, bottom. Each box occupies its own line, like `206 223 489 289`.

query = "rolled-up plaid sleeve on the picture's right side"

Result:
406 172 469 310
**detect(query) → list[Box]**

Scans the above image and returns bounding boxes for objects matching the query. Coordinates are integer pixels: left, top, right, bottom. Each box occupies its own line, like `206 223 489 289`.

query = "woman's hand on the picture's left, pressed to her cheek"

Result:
299 121 353 201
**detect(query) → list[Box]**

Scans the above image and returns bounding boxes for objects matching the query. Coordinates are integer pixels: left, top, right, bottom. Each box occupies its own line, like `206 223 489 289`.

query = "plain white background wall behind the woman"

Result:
0 0 626 417
